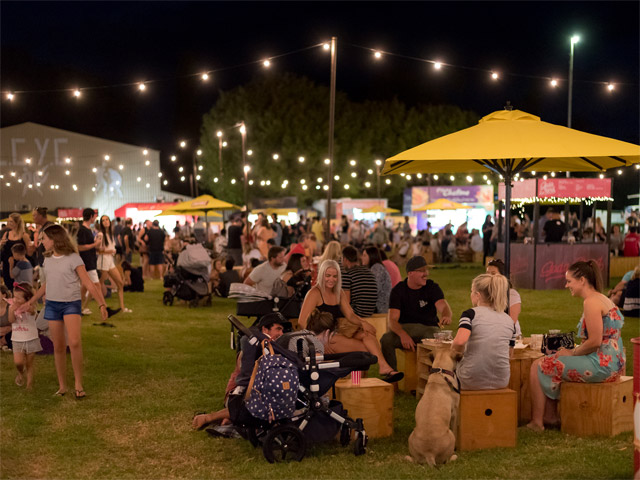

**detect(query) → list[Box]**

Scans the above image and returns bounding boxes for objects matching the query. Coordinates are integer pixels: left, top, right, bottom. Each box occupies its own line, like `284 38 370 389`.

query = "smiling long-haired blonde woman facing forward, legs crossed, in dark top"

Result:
298 260 404 383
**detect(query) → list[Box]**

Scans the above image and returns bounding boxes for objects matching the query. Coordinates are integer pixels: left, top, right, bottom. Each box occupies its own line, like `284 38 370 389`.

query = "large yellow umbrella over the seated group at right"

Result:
381 110 640 273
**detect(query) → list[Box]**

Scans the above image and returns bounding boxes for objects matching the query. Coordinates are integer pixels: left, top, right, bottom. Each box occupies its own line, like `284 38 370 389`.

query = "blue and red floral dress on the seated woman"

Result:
538 307 626 400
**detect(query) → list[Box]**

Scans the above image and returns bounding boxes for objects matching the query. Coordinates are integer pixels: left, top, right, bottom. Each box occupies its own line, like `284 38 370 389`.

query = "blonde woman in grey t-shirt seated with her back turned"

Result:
451 273 516 390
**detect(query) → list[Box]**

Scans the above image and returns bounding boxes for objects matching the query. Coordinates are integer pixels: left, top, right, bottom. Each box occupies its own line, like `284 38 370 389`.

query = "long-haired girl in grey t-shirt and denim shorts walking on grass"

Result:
17 225 108 399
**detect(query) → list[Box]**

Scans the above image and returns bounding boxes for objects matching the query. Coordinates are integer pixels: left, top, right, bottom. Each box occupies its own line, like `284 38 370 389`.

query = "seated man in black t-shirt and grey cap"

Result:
380 256 452 369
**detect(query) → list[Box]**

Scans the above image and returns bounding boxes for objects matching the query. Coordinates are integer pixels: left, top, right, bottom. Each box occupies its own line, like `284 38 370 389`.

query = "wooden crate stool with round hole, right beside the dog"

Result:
456 388 518 450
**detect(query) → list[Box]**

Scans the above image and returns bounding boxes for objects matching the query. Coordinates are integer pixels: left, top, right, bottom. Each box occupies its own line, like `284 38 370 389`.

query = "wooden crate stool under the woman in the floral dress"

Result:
560 377 633 436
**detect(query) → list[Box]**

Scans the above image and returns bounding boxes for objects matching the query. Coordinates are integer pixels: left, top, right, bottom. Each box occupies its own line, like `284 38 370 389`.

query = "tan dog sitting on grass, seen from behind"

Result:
409 345 462 467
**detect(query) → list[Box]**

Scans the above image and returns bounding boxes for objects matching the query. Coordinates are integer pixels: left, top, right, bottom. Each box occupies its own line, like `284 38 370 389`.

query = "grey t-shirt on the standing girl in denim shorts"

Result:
44 253 84 302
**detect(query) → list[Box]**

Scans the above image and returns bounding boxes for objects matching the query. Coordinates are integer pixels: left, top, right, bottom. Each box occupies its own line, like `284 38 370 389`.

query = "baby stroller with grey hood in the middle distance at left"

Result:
162 244 211 307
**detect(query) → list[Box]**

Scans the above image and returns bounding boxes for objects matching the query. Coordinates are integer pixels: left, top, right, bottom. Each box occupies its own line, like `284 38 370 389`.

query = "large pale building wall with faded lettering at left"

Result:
0 122 171 215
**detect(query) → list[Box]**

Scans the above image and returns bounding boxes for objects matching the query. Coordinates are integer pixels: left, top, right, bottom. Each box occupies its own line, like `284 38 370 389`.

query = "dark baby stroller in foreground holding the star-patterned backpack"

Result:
228 315 377 463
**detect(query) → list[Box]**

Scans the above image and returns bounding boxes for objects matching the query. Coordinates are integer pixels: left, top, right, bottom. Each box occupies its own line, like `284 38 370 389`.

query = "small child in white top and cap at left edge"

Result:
9 282 42 390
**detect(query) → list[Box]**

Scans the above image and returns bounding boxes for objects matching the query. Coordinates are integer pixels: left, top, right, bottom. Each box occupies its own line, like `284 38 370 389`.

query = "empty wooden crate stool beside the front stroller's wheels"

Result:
336 378 393 438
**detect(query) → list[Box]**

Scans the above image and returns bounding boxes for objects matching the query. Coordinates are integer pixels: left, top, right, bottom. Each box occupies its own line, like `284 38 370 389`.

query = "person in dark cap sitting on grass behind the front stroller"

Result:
191 314 284 438
